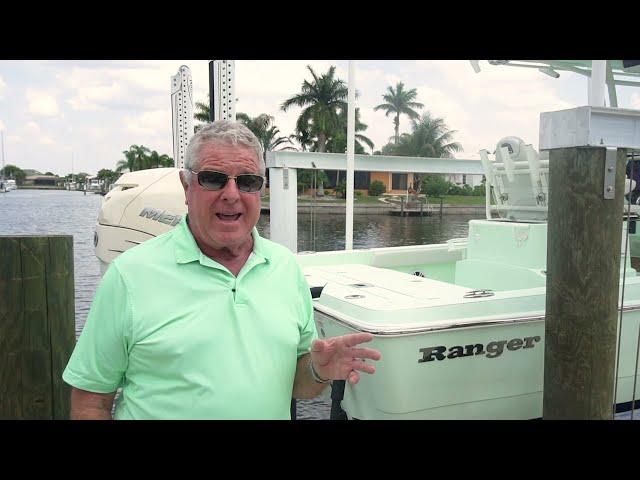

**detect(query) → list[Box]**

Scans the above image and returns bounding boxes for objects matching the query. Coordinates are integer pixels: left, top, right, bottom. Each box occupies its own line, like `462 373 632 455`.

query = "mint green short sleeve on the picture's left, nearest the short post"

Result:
62 262 133 393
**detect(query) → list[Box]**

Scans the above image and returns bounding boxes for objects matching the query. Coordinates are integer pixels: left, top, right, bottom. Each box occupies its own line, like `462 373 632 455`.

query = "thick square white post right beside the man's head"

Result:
269 167 298 253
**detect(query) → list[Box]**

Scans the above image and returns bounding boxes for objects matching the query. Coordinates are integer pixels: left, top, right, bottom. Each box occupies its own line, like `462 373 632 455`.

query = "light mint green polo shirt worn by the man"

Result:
62 217 317 419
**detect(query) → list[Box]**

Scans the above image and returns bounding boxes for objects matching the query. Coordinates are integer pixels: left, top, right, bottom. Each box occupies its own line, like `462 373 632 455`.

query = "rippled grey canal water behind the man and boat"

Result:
0 190 636 420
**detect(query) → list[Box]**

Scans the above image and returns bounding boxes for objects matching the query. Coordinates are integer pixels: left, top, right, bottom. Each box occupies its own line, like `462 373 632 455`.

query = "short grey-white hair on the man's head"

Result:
184 120 266 178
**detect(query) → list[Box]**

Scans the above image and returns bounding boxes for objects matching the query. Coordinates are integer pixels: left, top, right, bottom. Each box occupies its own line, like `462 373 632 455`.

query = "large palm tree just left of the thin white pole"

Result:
281 65 348 152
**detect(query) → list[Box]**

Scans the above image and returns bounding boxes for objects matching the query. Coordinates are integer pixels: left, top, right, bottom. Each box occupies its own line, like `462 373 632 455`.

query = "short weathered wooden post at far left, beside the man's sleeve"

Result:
0 235 75 420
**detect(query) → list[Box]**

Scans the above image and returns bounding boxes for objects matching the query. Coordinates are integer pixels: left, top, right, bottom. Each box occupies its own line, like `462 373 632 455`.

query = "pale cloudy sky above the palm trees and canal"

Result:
0 60 640 175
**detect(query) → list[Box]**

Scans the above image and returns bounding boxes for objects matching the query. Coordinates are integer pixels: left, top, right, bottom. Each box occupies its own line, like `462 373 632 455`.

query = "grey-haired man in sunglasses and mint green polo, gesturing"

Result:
63 121 380 419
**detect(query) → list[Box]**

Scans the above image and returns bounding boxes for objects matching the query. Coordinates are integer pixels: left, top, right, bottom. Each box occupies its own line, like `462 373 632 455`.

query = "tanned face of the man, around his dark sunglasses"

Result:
180 143 260 249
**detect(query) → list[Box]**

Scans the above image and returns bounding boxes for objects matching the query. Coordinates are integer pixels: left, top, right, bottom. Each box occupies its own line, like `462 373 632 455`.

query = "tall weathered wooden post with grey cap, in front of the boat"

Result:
540 107 640 420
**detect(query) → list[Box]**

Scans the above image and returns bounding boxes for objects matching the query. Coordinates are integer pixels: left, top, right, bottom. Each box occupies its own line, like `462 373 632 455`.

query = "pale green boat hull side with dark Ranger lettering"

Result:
315 310 640 420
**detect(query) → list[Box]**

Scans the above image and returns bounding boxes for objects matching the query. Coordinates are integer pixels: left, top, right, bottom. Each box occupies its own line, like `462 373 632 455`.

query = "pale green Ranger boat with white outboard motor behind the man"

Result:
96 61 640 419
